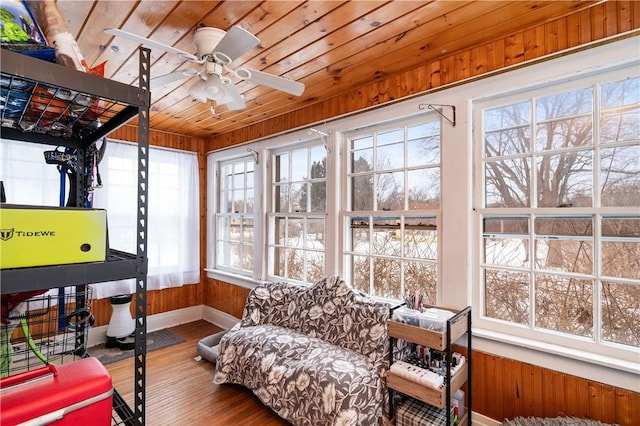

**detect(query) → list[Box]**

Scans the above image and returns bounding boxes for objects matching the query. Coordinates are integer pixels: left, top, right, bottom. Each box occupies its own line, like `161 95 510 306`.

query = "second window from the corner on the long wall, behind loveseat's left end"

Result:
268 141 327 283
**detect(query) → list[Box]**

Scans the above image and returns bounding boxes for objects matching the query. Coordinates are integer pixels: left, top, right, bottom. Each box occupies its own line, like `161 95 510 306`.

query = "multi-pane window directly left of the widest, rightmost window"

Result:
344 117 441 304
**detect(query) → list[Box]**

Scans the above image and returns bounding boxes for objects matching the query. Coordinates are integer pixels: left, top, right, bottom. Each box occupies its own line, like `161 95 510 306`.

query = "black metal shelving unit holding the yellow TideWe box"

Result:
0 48 151 425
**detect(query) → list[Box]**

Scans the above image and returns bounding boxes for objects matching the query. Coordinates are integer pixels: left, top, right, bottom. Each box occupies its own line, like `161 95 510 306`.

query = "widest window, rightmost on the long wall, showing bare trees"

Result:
479 72 640 358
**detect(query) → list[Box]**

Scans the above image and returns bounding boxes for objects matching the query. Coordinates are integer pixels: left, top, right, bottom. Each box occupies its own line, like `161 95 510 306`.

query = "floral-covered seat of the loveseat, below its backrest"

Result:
214 324 384 426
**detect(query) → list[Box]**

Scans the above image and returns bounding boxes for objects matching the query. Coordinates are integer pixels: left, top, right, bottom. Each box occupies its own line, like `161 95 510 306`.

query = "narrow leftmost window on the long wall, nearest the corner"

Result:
215 157 255 275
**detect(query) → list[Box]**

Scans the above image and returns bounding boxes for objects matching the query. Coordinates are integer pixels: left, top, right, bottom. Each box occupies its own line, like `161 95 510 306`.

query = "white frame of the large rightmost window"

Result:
472 47 640 379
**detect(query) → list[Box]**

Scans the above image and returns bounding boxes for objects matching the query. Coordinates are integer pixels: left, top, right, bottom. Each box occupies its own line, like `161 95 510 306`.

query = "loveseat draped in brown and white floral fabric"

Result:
214 277 389 426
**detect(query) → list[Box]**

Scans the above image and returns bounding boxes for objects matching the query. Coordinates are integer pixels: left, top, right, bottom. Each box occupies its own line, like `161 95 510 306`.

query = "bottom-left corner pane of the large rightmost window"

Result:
484 269 529 325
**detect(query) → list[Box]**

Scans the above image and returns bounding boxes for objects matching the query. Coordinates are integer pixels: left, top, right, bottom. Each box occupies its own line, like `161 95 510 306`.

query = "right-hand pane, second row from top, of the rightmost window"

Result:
600 146 640 207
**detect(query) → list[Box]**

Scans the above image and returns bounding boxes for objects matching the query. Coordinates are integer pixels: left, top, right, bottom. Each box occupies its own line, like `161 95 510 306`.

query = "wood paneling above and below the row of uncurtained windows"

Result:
204 1 640 426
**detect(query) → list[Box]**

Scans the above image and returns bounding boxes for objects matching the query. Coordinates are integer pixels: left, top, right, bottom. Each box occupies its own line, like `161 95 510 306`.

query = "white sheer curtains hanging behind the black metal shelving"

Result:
0 139 200 298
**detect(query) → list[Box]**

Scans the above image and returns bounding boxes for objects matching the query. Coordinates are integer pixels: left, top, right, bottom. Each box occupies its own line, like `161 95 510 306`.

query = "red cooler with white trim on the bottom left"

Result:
0 358 113 426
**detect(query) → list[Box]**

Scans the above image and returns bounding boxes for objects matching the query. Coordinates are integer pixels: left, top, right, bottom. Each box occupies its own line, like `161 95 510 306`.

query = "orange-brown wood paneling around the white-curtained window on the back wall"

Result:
91 125 207 326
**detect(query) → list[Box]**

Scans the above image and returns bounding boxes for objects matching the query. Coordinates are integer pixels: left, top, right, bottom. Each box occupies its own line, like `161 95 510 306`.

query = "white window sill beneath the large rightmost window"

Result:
472 328 640 392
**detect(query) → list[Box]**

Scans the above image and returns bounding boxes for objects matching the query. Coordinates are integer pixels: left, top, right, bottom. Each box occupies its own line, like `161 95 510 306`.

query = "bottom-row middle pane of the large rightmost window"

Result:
535 274 593 337
